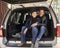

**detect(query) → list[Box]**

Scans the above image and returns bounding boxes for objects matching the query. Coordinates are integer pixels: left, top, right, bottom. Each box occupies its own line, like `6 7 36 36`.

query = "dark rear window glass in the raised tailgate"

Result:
3 0 47 4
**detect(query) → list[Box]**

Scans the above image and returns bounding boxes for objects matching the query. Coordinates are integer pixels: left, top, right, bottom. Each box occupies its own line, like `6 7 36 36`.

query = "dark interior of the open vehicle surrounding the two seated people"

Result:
6 7 54 41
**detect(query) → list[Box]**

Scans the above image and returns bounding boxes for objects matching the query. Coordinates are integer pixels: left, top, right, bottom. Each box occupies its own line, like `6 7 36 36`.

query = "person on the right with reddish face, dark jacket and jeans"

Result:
35 9 47 48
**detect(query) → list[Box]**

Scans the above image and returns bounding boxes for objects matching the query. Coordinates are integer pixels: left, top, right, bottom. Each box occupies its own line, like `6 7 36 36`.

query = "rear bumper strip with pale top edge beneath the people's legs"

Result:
6 41 53 47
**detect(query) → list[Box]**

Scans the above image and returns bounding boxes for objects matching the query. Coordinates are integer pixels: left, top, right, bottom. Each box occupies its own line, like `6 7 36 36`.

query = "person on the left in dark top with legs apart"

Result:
18 10 38 47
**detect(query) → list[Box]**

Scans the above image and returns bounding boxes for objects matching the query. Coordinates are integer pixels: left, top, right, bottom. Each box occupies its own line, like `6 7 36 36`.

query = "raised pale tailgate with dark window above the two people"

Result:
2 0 51 9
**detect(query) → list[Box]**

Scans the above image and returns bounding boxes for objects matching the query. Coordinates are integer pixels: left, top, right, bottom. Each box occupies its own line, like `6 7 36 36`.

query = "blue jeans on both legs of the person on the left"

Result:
21 26 38 44
